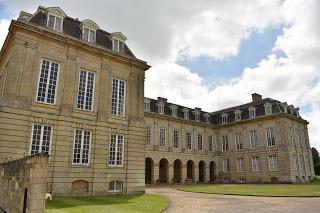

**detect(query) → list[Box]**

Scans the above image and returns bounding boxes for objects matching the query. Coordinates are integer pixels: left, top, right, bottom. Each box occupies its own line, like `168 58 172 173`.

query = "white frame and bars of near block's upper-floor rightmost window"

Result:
111 78 127 117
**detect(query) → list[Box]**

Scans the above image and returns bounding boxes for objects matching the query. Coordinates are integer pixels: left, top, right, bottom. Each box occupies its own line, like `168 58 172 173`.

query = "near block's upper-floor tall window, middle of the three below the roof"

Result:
77 70 95 111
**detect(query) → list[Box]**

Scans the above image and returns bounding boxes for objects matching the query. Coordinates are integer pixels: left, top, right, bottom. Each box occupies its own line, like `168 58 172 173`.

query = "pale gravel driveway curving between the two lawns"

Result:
146 187 320 213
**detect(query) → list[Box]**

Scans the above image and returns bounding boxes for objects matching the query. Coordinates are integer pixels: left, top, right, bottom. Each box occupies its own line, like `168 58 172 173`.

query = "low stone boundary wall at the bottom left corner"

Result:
0 154 49 213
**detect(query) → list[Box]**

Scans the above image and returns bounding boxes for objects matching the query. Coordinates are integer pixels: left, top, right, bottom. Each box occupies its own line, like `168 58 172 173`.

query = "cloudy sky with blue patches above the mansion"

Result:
0 0 320 149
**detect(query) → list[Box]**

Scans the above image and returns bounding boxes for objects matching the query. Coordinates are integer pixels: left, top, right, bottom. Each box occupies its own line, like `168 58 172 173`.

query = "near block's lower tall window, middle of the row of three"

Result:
72 129 91 165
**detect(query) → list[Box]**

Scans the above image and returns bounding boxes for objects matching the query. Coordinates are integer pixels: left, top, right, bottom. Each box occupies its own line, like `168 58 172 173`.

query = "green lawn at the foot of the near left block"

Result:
45 194 168 213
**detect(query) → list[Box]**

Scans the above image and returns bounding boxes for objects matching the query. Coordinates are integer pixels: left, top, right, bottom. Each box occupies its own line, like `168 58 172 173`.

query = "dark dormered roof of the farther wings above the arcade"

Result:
146 98 299 125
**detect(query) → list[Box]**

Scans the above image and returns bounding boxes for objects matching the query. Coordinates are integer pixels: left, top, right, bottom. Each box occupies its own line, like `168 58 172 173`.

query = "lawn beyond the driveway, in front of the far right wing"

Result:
178 176 320 197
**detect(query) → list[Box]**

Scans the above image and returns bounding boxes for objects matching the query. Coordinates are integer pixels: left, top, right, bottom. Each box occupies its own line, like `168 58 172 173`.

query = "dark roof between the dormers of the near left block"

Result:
29 10 136 58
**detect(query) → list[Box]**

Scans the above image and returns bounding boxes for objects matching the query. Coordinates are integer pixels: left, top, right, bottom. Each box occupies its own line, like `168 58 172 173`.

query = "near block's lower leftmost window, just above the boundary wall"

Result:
30 124 52 155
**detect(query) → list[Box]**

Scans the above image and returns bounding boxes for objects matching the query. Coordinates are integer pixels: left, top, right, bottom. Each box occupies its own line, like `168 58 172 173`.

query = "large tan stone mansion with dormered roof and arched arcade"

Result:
0 7 314 195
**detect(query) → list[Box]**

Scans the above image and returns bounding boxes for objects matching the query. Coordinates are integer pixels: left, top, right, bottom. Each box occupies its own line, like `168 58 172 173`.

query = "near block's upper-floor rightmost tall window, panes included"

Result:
111 78 126 117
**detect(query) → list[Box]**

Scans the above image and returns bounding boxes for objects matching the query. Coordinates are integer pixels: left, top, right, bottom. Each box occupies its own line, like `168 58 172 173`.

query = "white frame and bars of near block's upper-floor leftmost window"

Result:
36 58 60 105
